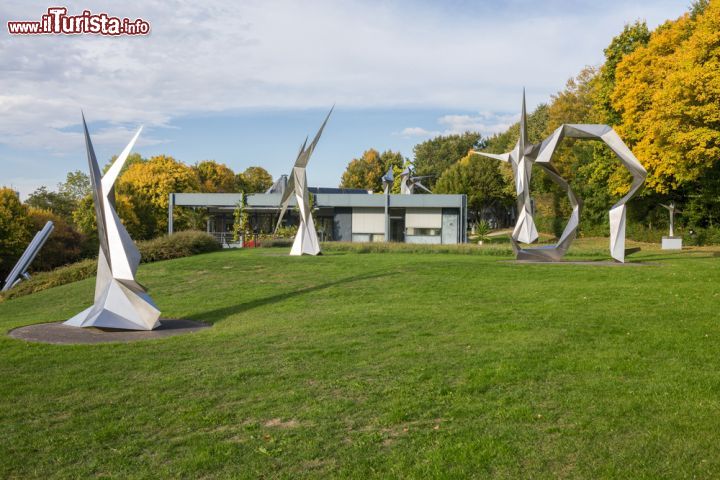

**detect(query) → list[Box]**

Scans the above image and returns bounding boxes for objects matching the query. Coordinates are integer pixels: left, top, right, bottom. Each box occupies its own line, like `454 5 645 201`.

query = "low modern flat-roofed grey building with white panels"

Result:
168 183 467 244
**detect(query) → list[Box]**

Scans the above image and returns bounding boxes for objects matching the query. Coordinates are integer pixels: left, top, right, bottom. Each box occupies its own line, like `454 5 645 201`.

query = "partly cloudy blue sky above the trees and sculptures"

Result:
0 0 687 197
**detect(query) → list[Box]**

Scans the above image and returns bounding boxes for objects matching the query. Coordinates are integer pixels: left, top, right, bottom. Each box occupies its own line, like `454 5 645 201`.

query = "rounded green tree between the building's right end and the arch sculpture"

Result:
434 154 514 218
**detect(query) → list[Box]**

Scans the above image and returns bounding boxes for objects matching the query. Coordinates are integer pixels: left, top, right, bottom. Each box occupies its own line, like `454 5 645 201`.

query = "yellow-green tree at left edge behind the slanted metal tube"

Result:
0 187 32 279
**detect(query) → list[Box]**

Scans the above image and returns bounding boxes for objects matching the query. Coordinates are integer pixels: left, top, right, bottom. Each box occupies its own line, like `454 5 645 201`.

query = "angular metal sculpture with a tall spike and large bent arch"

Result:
475 91 647 262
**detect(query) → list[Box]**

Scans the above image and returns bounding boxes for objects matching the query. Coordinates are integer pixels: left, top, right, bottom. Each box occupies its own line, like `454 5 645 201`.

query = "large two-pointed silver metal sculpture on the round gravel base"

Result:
65 115 160 330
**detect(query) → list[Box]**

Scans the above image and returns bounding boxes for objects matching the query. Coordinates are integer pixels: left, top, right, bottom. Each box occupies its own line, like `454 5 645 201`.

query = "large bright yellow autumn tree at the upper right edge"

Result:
612 2 720 194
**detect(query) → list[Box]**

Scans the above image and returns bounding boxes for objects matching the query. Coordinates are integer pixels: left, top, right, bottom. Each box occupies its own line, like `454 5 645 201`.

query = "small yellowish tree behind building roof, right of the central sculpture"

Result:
340 148 406 192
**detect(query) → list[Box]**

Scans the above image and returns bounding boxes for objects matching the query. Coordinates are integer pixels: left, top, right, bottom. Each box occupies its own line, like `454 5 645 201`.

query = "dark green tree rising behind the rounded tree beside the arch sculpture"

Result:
410 132 484 190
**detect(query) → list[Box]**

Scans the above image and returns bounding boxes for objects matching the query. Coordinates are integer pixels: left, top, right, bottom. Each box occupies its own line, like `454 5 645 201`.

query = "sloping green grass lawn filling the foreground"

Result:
0 242 720 479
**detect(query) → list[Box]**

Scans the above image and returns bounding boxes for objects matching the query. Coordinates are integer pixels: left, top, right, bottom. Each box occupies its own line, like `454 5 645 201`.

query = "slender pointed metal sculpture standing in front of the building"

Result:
275 107 335 255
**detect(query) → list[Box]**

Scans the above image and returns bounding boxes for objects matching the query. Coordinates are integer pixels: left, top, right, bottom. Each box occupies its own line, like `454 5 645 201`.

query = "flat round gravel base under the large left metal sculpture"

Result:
8 319 210 344
